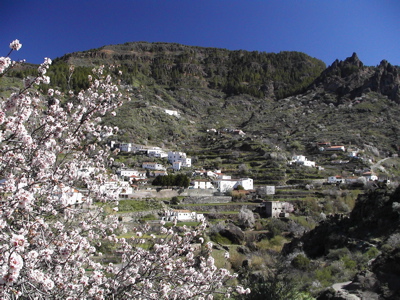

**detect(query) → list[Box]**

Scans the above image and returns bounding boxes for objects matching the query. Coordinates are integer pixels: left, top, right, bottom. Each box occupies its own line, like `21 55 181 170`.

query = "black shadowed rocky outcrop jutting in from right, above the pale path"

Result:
283 187 400 258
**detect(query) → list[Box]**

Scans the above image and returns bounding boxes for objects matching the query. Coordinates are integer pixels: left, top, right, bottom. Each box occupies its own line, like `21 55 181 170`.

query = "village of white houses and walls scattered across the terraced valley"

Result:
14 138 389 221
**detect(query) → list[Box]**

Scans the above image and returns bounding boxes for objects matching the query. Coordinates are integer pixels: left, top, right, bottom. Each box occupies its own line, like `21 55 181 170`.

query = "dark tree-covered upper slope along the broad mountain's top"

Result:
54 42 325 98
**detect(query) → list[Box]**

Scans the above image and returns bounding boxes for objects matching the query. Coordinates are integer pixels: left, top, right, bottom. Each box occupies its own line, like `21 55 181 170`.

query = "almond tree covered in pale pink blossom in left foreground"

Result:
0 40 249 299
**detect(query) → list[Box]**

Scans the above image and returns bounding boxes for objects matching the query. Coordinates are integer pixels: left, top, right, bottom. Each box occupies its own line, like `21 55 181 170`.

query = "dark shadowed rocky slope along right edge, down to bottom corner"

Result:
283 187 400 300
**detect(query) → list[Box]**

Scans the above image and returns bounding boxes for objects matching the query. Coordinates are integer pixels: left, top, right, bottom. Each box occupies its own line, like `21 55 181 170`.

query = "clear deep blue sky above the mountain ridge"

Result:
0 0 400 66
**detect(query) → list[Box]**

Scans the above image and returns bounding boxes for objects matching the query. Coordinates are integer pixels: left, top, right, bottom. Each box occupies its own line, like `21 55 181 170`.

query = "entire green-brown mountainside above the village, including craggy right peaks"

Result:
4 42 400 183
